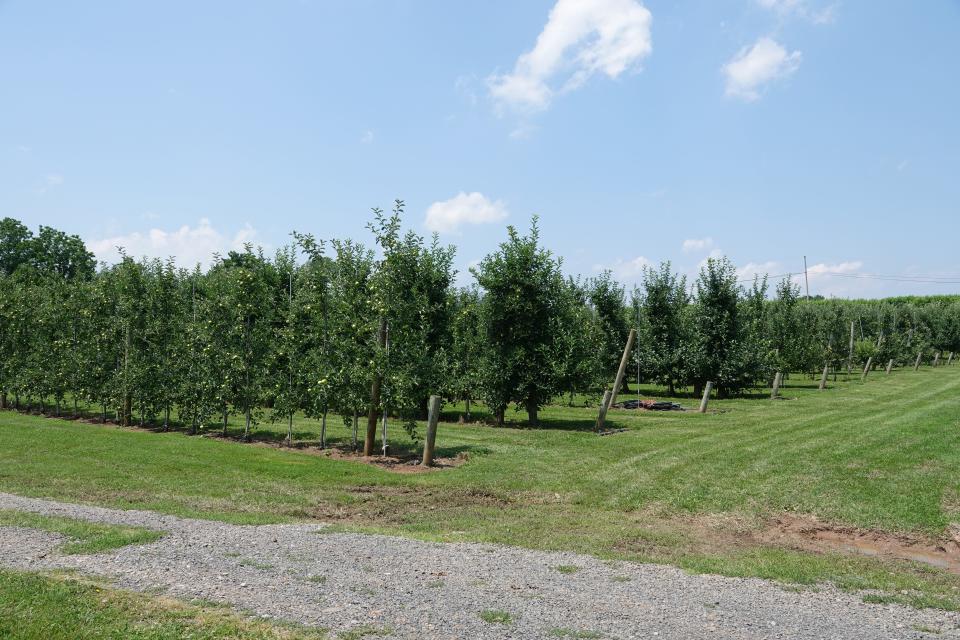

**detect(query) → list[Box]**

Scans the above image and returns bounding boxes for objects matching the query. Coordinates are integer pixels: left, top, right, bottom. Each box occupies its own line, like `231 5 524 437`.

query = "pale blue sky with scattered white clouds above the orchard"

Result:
0 0 960 297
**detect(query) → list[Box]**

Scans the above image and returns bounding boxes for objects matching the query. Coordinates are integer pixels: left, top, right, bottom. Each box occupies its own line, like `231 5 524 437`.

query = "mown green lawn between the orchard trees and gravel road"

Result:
0 367 960 609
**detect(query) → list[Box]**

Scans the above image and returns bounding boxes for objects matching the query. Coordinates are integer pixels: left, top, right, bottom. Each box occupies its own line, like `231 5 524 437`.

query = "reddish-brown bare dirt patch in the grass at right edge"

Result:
760 516 960 574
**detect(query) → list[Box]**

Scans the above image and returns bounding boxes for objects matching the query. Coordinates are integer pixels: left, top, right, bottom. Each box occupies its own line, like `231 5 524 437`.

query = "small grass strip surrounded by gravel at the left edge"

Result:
0 509 163 554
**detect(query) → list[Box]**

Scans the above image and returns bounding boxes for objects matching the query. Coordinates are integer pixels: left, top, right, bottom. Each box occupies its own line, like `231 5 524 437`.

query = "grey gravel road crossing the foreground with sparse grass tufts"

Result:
0 493 960 639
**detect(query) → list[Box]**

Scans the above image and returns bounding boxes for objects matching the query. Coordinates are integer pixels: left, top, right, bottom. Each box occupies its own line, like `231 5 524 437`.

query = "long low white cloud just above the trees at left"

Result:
86 218 257 268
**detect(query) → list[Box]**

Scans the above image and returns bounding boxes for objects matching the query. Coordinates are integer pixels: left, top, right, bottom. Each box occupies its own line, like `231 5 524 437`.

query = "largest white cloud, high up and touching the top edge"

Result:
487 0 653 112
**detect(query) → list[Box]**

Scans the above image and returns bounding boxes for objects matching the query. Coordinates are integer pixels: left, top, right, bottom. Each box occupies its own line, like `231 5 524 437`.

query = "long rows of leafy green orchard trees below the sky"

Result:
0 208 960 442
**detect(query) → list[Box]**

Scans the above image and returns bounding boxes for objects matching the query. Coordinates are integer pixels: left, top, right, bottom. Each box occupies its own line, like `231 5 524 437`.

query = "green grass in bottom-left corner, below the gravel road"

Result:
0 570 327 640
